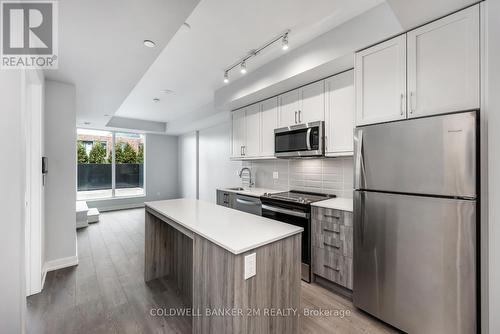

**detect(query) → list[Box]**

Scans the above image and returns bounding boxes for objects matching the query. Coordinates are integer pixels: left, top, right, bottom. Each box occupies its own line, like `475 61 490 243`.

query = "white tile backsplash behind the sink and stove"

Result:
242 157 353 198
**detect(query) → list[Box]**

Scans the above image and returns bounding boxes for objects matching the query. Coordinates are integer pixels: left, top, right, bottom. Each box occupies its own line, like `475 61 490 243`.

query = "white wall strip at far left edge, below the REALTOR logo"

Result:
0 70 26 333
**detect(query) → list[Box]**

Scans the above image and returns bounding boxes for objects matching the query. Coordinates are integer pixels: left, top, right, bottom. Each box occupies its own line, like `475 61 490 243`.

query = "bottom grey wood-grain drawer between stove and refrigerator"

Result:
313 247 352 289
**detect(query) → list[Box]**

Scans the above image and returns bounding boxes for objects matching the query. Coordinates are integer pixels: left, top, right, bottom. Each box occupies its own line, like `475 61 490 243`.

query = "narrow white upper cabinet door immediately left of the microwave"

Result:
260 97 278 158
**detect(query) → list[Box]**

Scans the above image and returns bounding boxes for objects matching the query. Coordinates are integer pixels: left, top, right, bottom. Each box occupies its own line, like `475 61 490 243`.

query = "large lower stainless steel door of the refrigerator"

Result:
353 191 476 334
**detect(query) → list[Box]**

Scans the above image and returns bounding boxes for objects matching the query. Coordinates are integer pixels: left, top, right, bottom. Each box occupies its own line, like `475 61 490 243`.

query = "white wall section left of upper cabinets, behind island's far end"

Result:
199 122 241 203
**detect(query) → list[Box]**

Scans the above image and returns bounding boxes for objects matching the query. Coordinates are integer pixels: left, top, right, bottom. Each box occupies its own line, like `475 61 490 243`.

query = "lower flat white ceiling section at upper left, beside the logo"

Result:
45 0 199 128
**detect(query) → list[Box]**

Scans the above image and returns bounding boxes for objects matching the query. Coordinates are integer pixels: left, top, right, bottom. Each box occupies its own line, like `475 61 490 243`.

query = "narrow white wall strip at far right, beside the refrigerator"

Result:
483 0 500 334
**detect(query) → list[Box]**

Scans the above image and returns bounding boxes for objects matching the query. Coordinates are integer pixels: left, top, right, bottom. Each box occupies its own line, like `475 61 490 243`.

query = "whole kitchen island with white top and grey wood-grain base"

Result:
144 199 303 333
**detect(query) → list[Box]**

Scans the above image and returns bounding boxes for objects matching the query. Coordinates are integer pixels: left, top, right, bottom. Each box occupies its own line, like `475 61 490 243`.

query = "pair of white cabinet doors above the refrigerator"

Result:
355 5 480 125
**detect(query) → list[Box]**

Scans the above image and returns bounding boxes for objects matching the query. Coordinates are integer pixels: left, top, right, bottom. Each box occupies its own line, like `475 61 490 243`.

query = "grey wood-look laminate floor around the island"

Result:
26 209 396 334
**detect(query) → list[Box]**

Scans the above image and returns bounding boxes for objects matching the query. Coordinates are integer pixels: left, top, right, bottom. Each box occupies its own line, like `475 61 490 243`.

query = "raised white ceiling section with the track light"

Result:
116 0 382 127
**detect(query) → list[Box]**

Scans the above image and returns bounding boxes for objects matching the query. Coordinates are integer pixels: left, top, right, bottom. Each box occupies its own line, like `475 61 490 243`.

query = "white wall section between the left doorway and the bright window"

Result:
45 80 77 261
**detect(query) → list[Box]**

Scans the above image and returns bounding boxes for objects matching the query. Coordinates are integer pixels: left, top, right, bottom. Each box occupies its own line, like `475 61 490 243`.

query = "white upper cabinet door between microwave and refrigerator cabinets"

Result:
325 71 354 156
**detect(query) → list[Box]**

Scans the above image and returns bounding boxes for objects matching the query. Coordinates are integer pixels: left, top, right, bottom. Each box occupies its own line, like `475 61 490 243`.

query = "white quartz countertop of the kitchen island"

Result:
145 198 304 254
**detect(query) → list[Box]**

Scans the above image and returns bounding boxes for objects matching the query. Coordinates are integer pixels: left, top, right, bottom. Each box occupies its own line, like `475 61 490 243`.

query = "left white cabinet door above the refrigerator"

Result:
354 35 406 125
